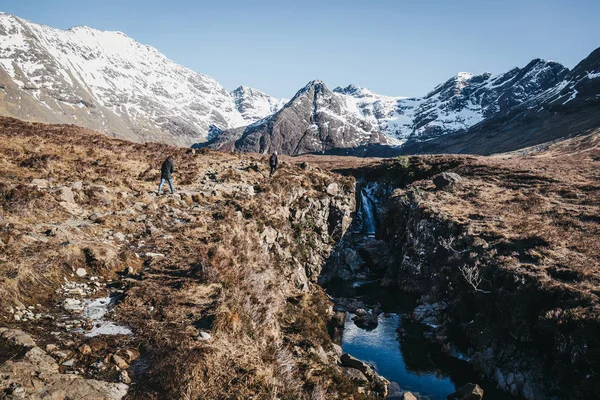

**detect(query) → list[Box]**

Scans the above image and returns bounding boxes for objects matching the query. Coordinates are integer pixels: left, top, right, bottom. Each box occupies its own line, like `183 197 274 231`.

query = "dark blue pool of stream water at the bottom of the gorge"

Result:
328 280 514 400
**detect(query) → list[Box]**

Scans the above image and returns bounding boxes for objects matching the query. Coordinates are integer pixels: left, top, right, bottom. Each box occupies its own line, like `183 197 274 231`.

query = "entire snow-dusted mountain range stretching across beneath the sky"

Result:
0 13 600 156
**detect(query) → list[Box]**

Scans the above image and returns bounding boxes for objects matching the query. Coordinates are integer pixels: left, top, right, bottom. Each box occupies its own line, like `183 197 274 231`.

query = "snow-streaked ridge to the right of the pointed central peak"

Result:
334 59 568 142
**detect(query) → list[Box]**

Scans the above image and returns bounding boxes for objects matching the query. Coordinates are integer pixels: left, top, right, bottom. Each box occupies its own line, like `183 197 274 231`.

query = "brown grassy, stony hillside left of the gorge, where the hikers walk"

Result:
0 118 378 399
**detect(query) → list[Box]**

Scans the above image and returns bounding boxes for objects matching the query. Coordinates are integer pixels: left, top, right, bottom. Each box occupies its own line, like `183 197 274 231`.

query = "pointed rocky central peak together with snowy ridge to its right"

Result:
205 59 569 154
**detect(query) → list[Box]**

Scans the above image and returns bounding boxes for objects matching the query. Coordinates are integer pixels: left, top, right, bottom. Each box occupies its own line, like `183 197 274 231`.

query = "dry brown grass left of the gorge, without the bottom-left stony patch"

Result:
0 118 366 399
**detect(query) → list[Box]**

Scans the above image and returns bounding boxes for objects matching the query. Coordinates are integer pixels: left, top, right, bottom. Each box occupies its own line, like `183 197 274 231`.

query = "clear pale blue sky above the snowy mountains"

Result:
0 0 600 97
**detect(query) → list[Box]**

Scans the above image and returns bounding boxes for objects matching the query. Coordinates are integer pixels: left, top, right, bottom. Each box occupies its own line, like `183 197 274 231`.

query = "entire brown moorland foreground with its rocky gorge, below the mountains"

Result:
0 114 600 399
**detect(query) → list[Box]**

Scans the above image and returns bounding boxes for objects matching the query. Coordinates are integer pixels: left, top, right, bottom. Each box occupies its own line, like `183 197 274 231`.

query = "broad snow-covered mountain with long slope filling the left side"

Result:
0 13 278 146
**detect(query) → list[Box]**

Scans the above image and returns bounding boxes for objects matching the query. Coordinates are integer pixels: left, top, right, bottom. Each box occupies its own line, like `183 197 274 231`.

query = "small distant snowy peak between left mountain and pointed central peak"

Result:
231 86 289 123
